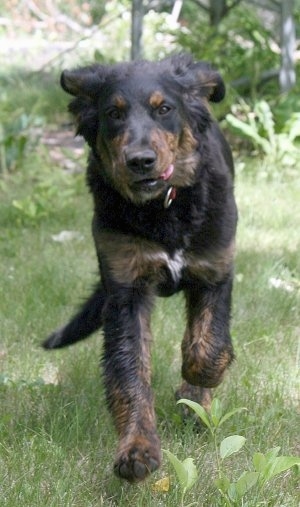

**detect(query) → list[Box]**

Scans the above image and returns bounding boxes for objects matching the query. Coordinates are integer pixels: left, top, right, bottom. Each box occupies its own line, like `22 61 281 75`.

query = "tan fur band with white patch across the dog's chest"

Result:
95 231 232 293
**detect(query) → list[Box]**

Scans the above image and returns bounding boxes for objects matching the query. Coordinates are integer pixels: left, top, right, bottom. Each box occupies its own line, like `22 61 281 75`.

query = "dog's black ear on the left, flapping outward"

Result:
60 65 106 98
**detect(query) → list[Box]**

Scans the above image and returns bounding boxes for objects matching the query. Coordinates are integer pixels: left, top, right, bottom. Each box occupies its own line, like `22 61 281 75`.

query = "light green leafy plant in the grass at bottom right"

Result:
164 398 300 507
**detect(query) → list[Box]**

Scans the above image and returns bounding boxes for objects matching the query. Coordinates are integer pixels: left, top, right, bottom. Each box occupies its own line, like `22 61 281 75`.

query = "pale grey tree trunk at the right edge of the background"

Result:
279 0 296 92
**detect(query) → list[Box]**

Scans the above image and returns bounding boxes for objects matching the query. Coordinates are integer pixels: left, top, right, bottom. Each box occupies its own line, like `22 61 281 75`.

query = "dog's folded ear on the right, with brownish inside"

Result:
193 62 226 102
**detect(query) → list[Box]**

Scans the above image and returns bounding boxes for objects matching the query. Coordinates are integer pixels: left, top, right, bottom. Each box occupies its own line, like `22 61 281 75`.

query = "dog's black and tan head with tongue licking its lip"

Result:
61 55 225 204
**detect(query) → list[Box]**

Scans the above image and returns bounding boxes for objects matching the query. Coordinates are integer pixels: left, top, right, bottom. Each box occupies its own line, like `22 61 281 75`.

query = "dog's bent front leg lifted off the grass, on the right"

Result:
177 274 233 408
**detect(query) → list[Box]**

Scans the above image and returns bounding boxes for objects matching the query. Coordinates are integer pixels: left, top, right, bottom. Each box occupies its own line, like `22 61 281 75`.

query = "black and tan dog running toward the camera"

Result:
43 54 237 482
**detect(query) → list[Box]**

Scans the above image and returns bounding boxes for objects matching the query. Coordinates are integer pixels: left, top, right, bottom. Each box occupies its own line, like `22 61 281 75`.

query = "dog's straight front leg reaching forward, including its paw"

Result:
103 285 161 482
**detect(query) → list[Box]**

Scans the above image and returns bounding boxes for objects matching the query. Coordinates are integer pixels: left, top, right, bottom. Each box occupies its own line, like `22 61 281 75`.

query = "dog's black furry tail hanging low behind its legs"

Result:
43 283 106 349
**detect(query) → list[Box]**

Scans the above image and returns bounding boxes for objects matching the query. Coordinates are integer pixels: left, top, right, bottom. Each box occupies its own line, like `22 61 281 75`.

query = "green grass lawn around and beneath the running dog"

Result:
0 161 300 507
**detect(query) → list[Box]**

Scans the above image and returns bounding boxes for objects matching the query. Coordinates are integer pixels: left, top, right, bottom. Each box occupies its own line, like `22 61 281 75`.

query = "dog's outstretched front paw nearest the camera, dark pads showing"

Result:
114 437 161 483
